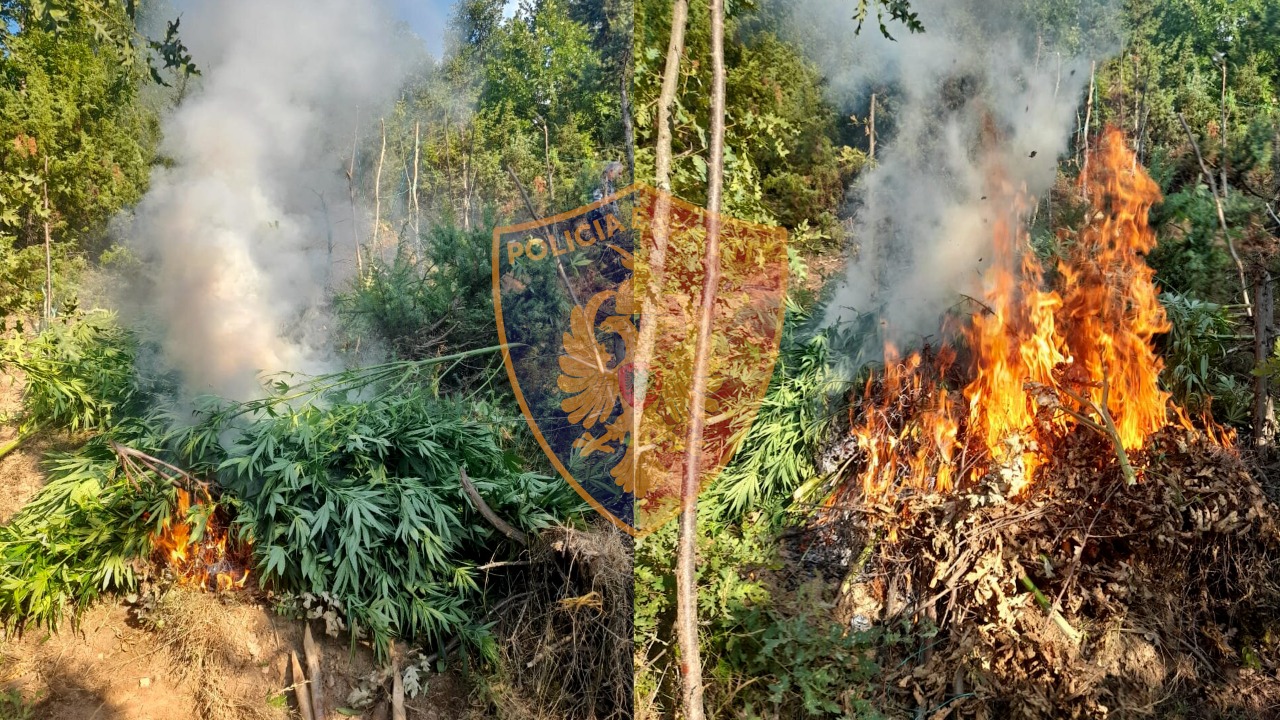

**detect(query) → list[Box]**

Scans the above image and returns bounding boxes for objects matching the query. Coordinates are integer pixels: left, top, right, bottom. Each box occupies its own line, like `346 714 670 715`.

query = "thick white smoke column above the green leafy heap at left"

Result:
125 0 408 400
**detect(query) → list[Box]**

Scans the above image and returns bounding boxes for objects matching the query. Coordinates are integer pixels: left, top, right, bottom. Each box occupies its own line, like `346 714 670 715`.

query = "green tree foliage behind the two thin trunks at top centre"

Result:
632 0 875 229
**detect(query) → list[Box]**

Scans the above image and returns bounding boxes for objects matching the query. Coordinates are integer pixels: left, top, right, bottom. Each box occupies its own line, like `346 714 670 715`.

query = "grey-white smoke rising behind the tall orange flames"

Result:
791 0 1121 353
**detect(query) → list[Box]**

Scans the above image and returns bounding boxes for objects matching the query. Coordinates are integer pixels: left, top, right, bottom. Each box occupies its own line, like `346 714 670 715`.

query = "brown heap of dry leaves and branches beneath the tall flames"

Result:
808 429 1280 719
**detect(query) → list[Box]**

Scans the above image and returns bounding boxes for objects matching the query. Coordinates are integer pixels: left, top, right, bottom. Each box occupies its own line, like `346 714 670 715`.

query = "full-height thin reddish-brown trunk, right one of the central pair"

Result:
676 0 724 720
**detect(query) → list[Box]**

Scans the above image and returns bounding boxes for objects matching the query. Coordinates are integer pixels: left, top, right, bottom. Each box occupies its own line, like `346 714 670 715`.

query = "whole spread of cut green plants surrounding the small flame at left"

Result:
0 322 580 652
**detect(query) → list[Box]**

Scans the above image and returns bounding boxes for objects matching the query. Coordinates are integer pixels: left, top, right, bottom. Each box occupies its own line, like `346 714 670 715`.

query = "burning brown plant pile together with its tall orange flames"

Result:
808 132 1280 717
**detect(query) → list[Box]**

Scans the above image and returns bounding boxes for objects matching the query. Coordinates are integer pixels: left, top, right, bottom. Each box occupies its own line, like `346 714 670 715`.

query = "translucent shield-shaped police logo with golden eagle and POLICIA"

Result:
493 184 787 536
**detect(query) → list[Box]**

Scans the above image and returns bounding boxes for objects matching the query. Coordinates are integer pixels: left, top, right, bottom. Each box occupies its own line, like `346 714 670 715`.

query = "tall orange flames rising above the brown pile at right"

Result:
852 128 1229 497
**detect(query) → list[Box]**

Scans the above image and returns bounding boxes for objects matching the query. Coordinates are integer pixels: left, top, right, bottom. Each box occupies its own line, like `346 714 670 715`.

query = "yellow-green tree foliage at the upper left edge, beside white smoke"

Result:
0 1 157 313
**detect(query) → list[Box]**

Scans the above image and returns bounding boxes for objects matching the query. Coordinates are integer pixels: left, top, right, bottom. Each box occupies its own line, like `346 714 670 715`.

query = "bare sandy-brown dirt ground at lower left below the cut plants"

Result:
0 378 470 720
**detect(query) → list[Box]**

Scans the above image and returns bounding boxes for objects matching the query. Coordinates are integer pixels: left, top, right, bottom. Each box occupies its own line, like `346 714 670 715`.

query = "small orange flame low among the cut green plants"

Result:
151 488 248 591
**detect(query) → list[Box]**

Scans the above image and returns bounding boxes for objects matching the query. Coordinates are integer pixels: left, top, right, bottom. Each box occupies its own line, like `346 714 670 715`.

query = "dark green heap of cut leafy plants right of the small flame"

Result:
210 393 571 650
